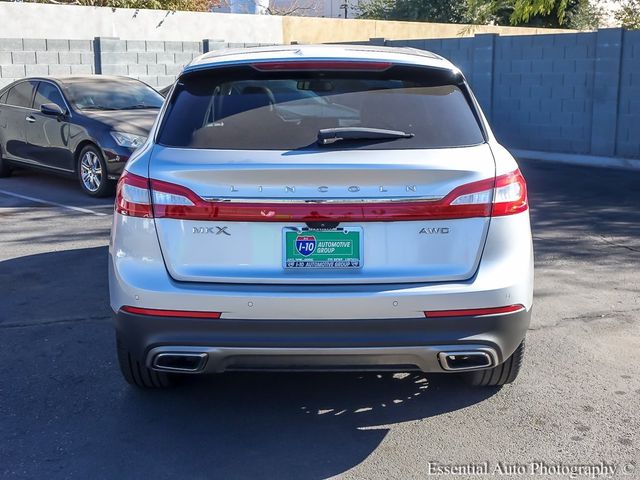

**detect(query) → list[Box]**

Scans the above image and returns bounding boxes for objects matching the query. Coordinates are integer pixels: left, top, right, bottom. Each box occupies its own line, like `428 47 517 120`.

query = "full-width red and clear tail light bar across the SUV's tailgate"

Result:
116 170 528 222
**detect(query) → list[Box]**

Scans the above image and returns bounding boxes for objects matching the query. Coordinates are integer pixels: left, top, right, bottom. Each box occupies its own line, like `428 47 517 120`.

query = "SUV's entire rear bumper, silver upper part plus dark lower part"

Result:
109 213 533 372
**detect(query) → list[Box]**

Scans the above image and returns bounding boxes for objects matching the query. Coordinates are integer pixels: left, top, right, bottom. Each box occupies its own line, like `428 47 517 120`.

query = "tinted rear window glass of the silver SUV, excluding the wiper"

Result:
158 67 484 150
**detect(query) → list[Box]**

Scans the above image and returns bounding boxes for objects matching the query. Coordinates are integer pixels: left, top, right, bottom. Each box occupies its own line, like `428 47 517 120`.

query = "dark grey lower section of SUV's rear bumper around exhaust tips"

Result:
115 311 531 373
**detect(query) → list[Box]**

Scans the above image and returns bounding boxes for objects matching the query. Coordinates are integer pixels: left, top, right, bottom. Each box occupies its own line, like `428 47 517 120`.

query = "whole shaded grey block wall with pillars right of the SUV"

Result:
369 28 640 159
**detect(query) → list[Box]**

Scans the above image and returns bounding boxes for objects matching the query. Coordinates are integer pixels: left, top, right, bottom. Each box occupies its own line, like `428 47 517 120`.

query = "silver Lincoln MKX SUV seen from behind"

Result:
109 46 533 387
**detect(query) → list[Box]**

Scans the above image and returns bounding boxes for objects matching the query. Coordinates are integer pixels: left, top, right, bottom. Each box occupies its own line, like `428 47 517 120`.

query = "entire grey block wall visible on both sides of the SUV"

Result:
0 29 640 159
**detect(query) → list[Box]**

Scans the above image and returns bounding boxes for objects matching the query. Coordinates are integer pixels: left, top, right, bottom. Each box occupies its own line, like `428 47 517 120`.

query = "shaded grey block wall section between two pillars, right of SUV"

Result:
491 33 597 154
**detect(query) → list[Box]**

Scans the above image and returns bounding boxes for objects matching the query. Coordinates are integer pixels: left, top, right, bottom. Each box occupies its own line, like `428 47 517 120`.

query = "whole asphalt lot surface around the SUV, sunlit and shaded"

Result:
0 161 640 480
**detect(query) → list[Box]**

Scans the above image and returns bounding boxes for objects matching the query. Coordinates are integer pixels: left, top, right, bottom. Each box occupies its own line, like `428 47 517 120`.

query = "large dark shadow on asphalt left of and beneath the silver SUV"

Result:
0 247 498 479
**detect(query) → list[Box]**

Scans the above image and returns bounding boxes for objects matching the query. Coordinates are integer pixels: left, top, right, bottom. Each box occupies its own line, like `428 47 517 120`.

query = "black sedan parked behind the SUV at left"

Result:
0 75 164 197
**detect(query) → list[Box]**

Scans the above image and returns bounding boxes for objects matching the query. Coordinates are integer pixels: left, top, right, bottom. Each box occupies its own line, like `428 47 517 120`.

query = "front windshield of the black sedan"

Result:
66 79 164 110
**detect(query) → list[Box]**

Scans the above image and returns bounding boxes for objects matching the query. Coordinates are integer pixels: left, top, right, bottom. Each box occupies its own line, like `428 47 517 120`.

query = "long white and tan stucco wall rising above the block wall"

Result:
0 2 571 44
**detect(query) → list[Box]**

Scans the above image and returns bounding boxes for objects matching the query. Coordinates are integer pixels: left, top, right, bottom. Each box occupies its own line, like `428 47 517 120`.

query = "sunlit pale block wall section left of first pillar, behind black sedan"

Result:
0 38 95 88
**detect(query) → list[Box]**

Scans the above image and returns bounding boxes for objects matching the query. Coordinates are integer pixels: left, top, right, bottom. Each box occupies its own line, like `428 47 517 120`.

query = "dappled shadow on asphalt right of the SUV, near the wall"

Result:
519 161 640 264
